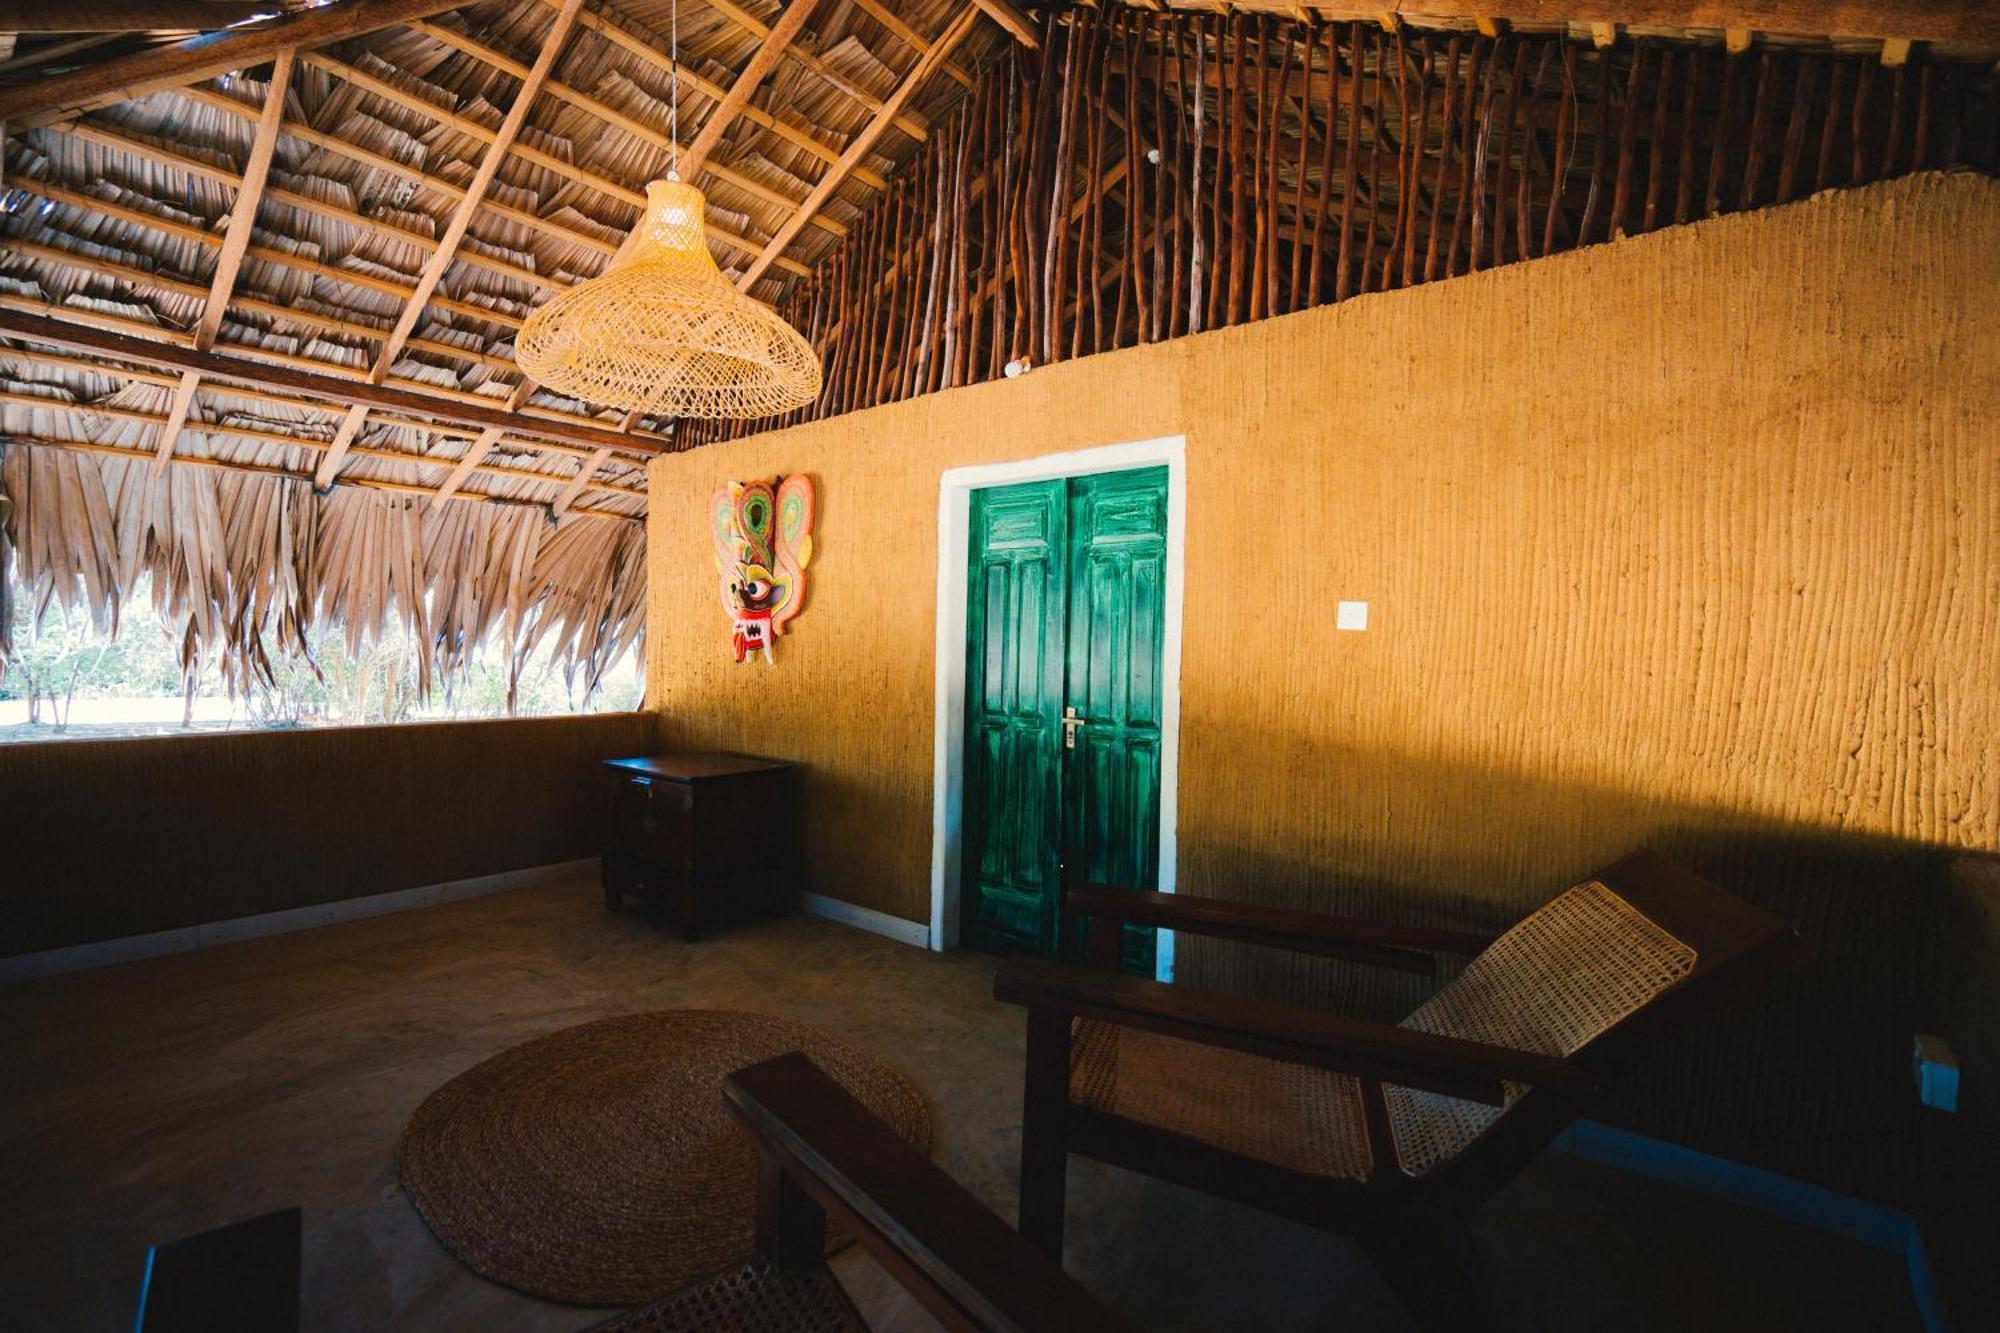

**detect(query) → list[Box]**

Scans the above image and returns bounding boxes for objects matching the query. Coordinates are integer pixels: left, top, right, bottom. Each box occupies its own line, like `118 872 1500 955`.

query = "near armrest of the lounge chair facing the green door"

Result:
994 959 1604 1107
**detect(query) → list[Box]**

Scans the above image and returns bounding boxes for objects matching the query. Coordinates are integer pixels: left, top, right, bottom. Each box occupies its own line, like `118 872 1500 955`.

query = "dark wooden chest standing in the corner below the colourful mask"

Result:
604 753 804 941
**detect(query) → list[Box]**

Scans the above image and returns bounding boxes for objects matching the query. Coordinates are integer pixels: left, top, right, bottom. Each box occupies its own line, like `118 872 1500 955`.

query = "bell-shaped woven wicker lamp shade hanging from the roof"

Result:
514 180 820 418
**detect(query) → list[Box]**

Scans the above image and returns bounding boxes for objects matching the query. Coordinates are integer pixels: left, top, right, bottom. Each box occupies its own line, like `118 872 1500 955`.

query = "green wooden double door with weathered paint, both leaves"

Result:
962 468 1166 960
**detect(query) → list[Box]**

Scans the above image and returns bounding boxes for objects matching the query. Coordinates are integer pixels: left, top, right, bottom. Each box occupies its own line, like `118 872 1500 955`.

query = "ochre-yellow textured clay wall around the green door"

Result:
648 176 2000 1201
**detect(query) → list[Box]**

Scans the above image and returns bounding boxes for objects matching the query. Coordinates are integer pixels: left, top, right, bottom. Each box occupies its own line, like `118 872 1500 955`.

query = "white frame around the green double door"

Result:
930 434 1188 981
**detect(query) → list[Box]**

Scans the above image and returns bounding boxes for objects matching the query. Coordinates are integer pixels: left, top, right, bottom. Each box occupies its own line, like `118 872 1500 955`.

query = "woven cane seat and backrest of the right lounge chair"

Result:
1070 881 1696 1183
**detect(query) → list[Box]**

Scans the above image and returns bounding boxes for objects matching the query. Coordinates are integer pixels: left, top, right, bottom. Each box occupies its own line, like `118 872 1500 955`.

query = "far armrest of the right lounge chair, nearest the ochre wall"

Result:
1064 885 1494 977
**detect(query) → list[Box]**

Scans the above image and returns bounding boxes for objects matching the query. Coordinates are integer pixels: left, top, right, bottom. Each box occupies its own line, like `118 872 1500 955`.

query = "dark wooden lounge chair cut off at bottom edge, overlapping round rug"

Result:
598 1051 1128 1333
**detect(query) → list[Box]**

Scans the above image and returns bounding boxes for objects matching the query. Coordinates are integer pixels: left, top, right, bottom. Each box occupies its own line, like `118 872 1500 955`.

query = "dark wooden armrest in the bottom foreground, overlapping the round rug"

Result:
722 1051 1130 1333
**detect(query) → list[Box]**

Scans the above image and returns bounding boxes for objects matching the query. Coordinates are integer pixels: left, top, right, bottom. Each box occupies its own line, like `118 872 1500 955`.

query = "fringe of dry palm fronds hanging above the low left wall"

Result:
0 442 646 693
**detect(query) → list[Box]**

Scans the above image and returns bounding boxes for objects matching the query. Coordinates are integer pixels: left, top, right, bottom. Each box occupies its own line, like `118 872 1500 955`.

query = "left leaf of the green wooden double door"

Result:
964 480 1068 951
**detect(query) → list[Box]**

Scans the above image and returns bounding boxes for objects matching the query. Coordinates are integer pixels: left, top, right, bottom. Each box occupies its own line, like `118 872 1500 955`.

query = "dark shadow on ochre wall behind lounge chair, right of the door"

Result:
1180 740 1960 1209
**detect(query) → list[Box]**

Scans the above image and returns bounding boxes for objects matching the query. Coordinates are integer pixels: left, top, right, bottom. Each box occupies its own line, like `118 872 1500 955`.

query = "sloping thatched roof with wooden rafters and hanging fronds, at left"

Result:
0 0 1006 681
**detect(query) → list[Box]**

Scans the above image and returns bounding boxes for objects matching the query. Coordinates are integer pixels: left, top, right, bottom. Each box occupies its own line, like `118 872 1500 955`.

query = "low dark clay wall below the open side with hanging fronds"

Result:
0 713 656 957
